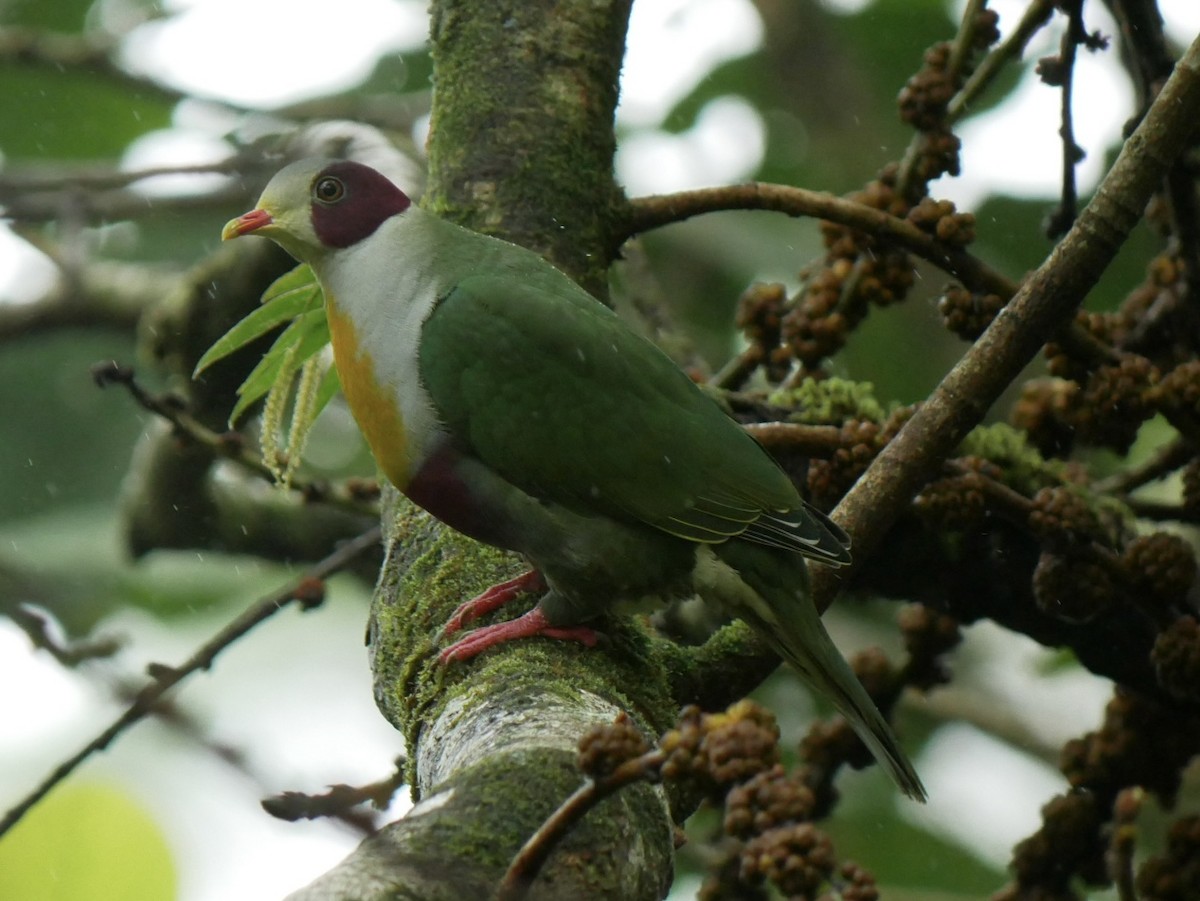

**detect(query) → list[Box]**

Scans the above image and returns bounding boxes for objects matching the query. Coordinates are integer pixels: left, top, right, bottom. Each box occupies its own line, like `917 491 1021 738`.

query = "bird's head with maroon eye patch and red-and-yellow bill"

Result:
221 160 412 263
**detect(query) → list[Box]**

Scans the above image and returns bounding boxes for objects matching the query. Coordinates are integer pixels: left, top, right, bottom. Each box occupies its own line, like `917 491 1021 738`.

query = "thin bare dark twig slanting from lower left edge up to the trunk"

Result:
0 527 380 836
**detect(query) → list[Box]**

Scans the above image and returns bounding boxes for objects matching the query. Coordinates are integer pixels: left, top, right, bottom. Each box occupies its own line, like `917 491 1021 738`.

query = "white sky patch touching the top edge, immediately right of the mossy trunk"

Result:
617 0 762 126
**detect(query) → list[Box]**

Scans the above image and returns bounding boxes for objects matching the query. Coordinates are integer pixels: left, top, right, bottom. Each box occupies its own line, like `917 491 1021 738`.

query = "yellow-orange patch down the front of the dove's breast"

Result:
325 299 412 489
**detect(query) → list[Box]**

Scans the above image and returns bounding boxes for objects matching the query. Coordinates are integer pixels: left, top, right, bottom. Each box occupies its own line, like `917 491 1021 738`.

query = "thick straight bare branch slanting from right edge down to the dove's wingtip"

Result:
812 37 1200 609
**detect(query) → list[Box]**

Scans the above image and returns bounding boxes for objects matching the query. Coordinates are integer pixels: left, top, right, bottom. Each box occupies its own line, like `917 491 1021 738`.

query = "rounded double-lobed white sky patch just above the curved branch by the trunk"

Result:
617 96 767 194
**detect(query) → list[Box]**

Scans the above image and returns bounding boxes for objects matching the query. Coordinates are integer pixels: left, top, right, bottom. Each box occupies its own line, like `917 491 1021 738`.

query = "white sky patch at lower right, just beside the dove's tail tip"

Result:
899 723 1067 869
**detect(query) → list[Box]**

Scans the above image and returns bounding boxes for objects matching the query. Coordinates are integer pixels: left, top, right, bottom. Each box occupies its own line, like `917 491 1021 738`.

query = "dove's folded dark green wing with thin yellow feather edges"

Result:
420 270 845 559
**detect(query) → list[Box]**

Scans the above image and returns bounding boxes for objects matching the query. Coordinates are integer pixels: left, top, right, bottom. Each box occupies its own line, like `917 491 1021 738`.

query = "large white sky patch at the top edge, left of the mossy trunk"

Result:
124 0 428 108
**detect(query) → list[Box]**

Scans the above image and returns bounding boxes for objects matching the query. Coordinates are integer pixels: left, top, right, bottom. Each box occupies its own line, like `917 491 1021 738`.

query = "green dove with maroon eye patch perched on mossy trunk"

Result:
222 160 925 800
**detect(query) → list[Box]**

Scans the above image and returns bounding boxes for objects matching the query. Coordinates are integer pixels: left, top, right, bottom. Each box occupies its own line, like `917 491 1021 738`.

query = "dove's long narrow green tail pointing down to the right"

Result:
700 541 925 801
